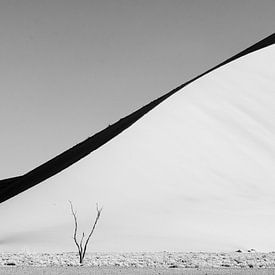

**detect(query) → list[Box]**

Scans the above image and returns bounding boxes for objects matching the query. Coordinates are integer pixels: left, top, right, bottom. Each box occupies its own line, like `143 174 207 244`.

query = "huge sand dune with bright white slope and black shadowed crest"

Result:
0 32 275 252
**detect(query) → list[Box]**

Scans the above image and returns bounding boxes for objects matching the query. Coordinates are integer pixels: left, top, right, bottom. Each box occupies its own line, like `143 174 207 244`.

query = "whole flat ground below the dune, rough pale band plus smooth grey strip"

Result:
0 253 275 275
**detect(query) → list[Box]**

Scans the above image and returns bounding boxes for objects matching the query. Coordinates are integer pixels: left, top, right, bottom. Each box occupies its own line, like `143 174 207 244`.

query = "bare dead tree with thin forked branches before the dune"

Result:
69 201 102 264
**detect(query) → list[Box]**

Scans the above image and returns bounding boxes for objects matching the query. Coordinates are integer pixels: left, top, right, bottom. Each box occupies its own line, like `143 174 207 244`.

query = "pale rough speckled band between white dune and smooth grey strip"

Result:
0 251 275 270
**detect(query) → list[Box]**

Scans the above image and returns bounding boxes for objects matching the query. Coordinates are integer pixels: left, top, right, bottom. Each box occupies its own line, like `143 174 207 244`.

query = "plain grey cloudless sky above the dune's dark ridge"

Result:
0 0 275 178
